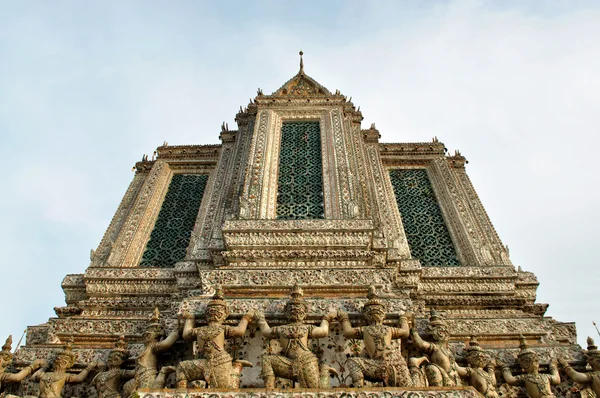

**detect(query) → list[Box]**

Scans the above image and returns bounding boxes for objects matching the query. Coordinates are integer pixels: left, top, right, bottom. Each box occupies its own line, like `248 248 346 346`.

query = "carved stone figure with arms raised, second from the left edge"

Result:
32 337 98 398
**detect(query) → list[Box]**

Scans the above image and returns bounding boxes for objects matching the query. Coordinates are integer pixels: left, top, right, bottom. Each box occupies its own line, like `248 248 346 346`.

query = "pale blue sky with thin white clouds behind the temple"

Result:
0 0 600 352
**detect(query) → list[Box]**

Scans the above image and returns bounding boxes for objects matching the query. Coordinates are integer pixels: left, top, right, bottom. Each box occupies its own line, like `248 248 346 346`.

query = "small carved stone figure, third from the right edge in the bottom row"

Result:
457 337 498 398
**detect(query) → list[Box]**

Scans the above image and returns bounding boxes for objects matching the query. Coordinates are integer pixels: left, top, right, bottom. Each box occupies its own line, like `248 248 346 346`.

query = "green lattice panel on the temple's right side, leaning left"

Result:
390 169 460 267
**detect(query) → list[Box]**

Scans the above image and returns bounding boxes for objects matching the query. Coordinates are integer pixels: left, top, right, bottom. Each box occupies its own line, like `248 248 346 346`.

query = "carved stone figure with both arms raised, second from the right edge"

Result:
499 335 560 398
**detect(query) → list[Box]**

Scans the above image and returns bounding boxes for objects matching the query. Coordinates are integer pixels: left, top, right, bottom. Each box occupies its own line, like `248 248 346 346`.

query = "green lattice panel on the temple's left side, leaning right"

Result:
140 174 208 268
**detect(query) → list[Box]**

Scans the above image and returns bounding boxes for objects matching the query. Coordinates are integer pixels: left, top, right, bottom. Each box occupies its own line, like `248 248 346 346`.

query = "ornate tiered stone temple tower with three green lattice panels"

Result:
5 56 593 398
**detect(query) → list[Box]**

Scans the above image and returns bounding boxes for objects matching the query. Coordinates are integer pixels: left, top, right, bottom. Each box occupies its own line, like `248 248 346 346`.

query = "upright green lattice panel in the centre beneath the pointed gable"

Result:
277 122 325 220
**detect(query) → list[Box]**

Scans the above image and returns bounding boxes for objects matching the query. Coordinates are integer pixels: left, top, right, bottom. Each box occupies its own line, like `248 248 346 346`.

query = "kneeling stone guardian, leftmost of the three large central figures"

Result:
177 287 255 389
